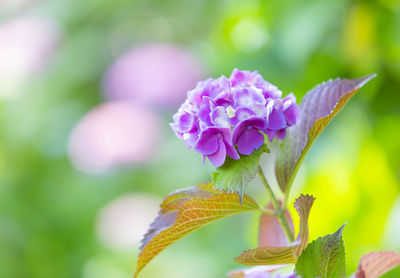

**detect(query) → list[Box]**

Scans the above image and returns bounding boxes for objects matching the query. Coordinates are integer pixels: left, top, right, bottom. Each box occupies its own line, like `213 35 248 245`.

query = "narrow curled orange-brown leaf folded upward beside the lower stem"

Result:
234 195 315 265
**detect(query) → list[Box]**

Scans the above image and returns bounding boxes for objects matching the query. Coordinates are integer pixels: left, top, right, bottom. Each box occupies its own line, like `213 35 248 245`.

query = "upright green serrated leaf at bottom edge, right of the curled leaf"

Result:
295 225 346 278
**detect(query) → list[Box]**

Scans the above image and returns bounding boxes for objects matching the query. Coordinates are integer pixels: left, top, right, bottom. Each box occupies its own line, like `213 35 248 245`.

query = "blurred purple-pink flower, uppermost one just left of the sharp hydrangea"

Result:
104 44 202 107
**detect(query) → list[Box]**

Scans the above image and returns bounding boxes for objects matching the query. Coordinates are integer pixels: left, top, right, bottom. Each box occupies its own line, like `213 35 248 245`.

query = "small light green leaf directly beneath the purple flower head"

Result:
212 145 269 200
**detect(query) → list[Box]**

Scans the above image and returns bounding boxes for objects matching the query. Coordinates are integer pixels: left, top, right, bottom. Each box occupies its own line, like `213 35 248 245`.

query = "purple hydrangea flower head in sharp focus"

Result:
171 69 300 167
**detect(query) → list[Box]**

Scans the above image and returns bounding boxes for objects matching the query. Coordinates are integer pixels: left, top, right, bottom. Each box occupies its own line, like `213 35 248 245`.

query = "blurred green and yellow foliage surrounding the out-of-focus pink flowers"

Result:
0 0 400 278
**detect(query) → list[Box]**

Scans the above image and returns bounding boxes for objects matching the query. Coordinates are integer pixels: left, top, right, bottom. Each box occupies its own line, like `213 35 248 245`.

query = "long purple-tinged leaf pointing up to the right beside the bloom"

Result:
275 74 376 192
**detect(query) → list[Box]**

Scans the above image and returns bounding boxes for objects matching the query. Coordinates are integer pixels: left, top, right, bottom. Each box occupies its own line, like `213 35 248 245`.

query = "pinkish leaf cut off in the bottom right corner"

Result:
356 251 400 278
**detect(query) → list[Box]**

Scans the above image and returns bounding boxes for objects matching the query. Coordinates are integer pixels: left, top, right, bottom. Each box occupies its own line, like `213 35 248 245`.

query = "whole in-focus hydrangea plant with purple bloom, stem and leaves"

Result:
135 69 400 278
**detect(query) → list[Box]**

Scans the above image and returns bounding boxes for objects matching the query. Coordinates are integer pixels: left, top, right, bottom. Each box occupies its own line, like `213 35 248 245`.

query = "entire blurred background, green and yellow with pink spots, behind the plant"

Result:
0 0 400 278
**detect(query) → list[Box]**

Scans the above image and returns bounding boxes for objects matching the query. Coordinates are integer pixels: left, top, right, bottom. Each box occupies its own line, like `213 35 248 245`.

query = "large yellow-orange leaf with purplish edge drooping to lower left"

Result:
134 183 259 277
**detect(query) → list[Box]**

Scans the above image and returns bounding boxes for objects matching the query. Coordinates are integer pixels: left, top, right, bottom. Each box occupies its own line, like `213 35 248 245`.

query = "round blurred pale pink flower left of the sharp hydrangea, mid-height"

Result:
68 102 161 173
